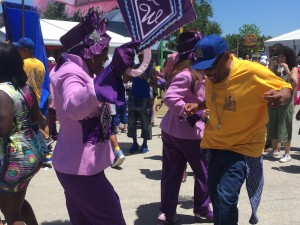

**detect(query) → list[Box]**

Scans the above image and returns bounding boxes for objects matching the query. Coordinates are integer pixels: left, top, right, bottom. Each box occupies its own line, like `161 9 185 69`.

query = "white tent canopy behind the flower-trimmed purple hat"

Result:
0 19 131 54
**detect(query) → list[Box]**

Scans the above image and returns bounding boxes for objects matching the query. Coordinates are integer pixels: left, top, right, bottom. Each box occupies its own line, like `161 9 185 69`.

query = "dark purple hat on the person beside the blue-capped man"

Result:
176 31 202 63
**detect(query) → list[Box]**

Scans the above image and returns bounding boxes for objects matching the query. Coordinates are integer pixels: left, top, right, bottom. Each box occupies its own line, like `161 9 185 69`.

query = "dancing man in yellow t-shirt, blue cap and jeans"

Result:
186 35 291 225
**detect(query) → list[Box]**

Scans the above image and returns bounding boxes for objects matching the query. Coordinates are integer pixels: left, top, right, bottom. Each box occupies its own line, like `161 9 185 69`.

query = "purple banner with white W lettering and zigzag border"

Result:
118 0 196 50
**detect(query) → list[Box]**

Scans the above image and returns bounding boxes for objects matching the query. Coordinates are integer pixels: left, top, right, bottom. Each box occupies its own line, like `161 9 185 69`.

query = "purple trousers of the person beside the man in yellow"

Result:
160 131 211 218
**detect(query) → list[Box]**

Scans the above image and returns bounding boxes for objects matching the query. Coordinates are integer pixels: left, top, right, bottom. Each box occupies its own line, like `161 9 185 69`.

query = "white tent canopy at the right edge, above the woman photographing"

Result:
264 29 300 54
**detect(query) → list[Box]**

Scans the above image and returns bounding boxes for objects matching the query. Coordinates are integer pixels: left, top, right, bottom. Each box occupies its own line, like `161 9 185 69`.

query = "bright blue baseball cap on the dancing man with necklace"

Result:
191 34 229 70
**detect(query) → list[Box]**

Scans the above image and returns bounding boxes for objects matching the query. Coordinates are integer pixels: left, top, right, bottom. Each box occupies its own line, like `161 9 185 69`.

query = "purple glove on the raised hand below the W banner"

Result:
110 41 140 76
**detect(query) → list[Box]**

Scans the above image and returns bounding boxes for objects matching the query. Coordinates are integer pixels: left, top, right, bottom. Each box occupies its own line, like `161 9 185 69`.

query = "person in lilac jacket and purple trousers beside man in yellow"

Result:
158 31 213 225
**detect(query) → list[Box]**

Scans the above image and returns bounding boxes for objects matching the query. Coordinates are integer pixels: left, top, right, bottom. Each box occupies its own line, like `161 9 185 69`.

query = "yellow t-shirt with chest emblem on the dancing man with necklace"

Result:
201 57 292 157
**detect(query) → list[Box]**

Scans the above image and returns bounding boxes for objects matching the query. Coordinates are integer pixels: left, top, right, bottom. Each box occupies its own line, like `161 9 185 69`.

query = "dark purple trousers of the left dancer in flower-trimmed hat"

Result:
55 171 126 225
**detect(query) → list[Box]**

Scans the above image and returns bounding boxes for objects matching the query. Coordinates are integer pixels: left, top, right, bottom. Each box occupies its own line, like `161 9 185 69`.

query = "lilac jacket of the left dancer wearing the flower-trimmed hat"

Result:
50 53 113 175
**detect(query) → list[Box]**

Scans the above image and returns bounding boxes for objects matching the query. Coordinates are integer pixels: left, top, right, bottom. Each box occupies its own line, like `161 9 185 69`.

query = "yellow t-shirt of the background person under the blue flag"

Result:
23 58 46 102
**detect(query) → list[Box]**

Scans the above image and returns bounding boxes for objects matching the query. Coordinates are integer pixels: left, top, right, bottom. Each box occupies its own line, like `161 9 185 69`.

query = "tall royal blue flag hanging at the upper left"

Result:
2 2 50 115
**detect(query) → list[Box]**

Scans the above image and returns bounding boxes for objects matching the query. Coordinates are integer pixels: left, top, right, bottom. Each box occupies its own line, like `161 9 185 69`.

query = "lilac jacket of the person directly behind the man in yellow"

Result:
160 69 205 140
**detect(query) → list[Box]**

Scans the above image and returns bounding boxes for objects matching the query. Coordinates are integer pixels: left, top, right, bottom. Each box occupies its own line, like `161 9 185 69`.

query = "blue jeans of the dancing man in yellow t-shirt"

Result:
208 150 247 225
